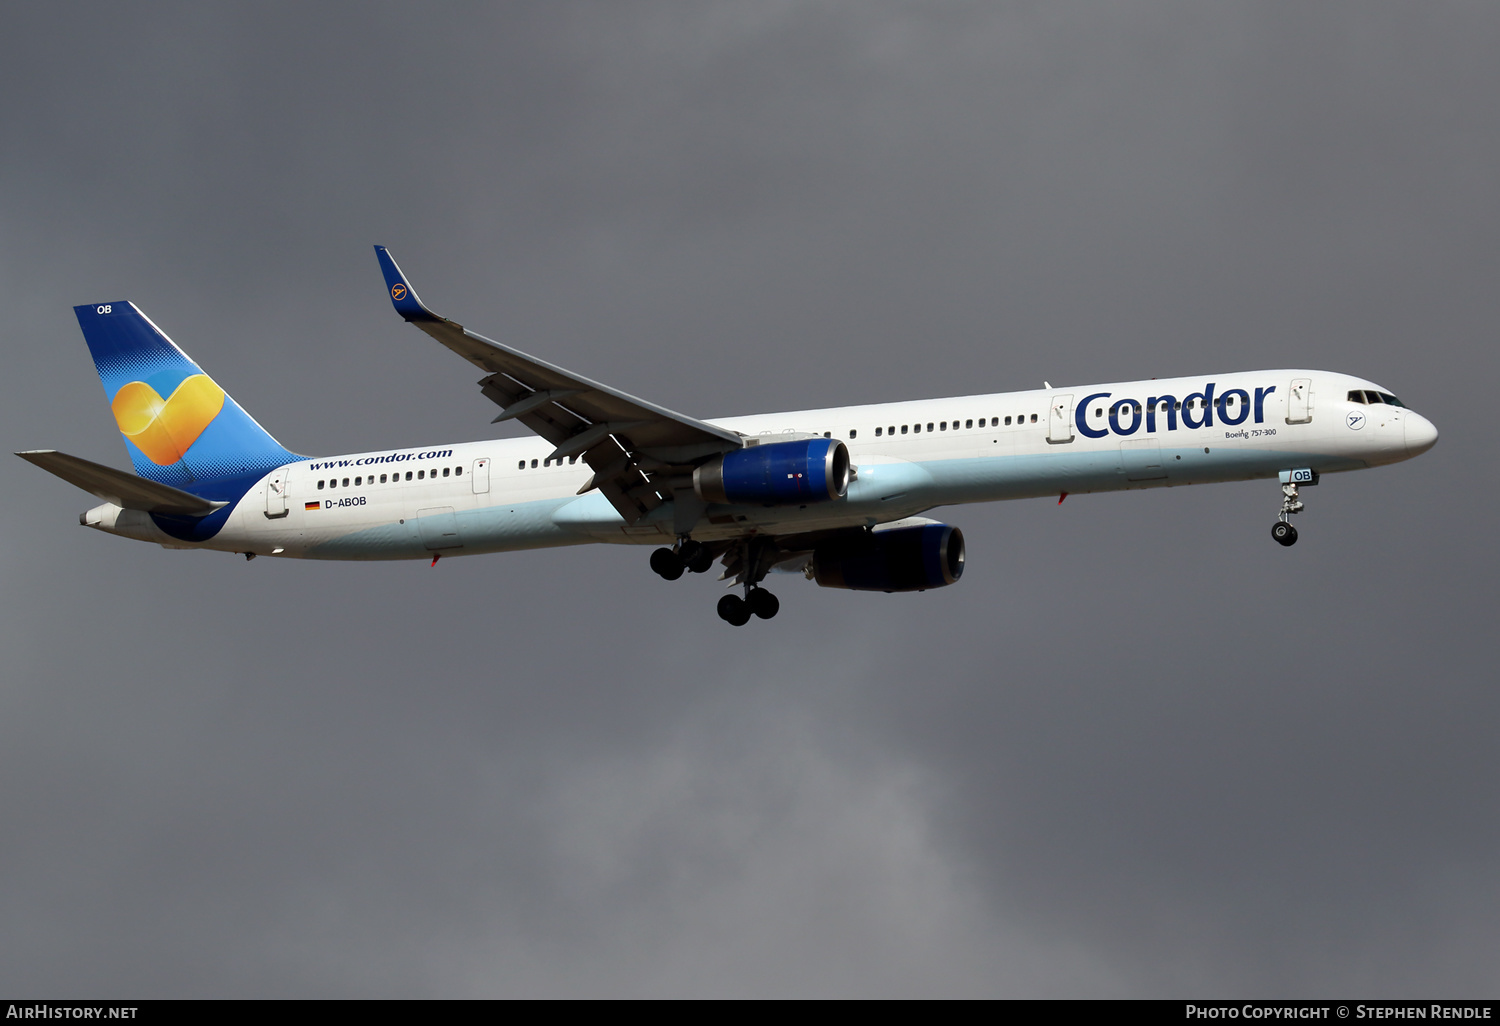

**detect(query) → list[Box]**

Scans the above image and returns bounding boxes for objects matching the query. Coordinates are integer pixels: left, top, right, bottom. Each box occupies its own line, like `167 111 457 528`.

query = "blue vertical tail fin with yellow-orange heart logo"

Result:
74 302 300 492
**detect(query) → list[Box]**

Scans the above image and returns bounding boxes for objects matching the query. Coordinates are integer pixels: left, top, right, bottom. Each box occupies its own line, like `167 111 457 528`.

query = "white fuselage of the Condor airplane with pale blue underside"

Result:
84 371 1437 560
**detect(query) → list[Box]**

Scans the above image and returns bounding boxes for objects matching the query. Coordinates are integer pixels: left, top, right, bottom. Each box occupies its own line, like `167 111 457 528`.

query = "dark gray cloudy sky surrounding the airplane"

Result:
0 2 1500 996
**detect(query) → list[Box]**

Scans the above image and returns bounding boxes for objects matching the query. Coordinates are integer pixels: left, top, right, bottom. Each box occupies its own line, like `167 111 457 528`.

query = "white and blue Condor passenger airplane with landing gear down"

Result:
17 246 1437 627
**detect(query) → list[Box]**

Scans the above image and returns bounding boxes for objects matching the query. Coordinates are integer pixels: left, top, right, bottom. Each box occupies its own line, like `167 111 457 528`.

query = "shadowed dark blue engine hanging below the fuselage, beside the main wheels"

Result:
813 524 963 591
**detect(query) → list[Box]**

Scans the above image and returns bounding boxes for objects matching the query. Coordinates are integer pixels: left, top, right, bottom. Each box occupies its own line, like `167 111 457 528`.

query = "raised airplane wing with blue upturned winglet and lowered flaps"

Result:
375 246 744 524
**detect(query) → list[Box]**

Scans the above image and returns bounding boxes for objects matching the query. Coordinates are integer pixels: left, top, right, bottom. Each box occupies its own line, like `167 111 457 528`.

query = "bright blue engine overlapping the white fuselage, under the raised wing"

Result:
693 438 849 506
